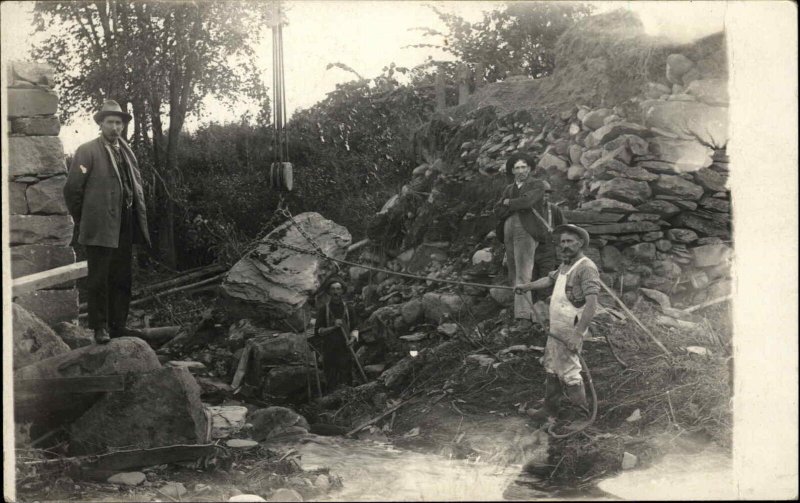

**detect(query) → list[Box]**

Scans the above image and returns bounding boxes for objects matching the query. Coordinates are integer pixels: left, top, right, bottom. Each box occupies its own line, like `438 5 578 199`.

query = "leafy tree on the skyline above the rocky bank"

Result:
414 2 592 82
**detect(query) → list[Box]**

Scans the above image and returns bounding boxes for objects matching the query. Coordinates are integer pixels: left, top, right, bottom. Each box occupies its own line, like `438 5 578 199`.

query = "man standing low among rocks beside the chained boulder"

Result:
314 276 358 393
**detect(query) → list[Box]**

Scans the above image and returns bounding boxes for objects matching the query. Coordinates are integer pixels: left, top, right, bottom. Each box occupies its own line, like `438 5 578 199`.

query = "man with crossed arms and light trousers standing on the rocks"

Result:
495 154 548 330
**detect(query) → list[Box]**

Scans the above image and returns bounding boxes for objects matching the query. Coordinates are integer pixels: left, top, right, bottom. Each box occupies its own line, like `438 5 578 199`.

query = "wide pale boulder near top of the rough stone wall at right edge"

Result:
642 100 728 148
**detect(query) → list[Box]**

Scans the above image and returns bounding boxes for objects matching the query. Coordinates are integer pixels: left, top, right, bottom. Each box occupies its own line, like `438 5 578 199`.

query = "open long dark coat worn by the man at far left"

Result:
64 137 150 248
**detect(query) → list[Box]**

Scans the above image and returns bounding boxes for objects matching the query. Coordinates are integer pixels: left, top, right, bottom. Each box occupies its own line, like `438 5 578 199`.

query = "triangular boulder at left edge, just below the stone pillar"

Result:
12 304 70 369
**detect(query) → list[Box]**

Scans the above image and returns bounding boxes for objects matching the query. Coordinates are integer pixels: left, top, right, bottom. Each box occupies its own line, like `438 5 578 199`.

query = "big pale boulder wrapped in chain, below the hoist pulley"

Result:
222 212 352 328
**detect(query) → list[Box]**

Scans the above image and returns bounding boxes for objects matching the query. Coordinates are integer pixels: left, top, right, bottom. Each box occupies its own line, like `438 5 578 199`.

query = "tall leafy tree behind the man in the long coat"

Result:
34 0 269 267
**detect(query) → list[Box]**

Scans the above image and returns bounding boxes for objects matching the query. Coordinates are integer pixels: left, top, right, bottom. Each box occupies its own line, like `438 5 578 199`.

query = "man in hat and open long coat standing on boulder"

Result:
64 100 150 344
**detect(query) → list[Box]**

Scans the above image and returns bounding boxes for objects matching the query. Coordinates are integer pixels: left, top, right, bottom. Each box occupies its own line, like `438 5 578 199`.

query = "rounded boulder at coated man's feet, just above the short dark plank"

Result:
14 334 161 379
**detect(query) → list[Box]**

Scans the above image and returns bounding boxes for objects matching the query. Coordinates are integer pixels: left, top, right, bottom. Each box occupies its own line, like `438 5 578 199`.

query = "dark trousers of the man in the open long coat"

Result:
86 209 135 336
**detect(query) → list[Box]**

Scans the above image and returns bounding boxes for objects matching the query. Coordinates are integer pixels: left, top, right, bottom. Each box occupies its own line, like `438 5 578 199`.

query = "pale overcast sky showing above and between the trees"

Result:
2 0 727 152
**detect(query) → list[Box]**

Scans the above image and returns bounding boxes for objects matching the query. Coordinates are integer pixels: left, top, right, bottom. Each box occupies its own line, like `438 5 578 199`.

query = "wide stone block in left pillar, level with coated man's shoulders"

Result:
8 136 67 180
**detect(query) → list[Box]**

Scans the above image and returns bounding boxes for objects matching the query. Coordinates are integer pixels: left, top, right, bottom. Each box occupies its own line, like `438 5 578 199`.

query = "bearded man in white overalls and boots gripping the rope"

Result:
517 224 600 421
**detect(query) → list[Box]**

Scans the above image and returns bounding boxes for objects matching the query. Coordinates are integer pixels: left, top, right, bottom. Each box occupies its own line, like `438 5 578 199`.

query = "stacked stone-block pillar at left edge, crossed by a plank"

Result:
6 61 78 325
